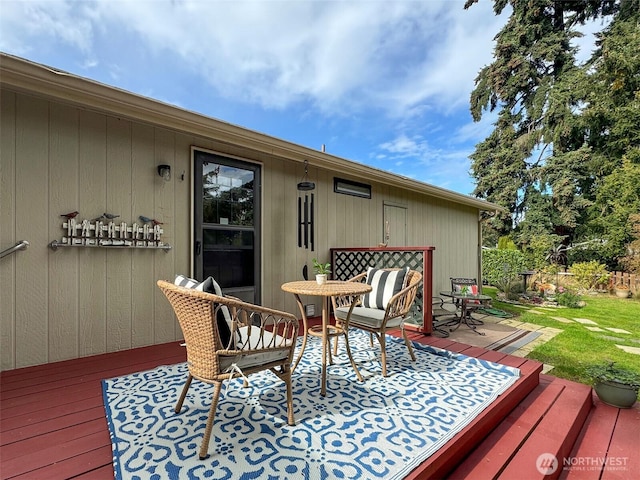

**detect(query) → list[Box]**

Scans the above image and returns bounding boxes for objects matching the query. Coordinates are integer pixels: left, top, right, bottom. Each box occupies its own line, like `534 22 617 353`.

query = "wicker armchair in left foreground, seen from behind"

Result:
158 280 298 460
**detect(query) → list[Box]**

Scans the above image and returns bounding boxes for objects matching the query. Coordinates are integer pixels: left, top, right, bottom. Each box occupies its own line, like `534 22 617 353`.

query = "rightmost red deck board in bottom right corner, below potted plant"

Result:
602 402 640 480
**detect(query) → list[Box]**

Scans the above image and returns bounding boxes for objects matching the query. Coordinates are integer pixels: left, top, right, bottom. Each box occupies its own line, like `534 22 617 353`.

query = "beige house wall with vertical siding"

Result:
0 90 478 370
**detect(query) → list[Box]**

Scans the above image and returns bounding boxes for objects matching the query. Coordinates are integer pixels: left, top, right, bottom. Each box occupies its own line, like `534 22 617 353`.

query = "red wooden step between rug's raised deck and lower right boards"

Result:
449 375 593 480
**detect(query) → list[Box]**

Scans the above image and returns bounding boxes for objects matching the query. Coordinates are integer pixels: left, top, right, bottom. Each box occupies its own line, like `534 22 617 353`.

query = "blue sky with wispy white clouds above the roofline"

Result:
0 0 600 194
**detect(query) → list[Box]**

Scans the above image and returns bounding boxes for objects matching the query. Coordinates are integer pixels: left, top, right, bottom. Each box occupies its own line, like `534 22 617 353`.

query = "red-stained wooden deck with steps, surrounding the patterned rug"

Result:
0 324 640 480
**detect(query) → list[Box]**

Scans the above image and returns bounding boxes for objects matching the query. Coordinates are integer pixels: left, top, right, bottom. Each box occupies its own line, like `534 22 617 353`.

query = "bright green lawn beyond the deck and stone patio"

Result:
483 287 640 384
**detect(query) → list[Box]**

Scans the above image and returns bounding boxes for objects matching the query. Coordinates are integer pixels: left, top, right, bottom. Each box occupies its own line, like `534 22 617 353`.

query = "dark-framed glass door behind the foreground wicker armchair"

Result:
193 150 261 303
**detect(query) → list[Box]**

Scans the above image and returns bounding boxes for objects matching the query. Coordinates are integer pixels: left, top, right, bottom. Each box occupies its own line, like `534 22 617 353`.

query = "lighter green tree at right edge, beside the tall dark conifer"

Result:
582 0 640 270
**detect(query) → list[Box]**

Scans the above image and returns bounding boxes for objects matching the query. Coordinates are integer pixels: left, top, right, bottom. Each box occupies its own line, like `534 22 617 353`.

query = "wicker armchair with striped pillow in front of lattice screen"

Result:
331 268 422 377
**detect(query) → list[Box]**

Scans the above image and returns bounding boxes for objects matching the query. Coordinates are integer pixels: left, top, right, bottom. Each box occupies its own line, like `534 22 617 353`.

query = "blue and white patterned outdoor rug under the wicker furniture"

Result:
103 330 520 479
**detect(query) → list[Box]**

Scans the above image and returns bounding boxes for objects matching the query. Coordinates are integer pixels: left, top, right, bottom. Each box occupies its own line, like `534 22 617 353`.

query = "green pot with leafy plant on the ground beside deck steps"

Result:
587 362 640 408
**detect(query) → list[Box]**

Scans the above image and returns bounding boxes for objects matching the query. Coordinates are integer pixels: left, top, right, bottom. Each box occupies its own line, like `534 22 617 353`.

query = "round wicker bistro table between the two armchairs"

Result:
281 280 371 396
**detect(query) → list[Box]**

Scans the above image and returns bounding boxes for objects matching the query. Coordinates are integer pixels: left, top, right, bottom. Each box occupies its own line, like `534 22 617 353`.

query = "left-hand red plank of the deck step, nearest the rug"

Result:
449 384 564 479
